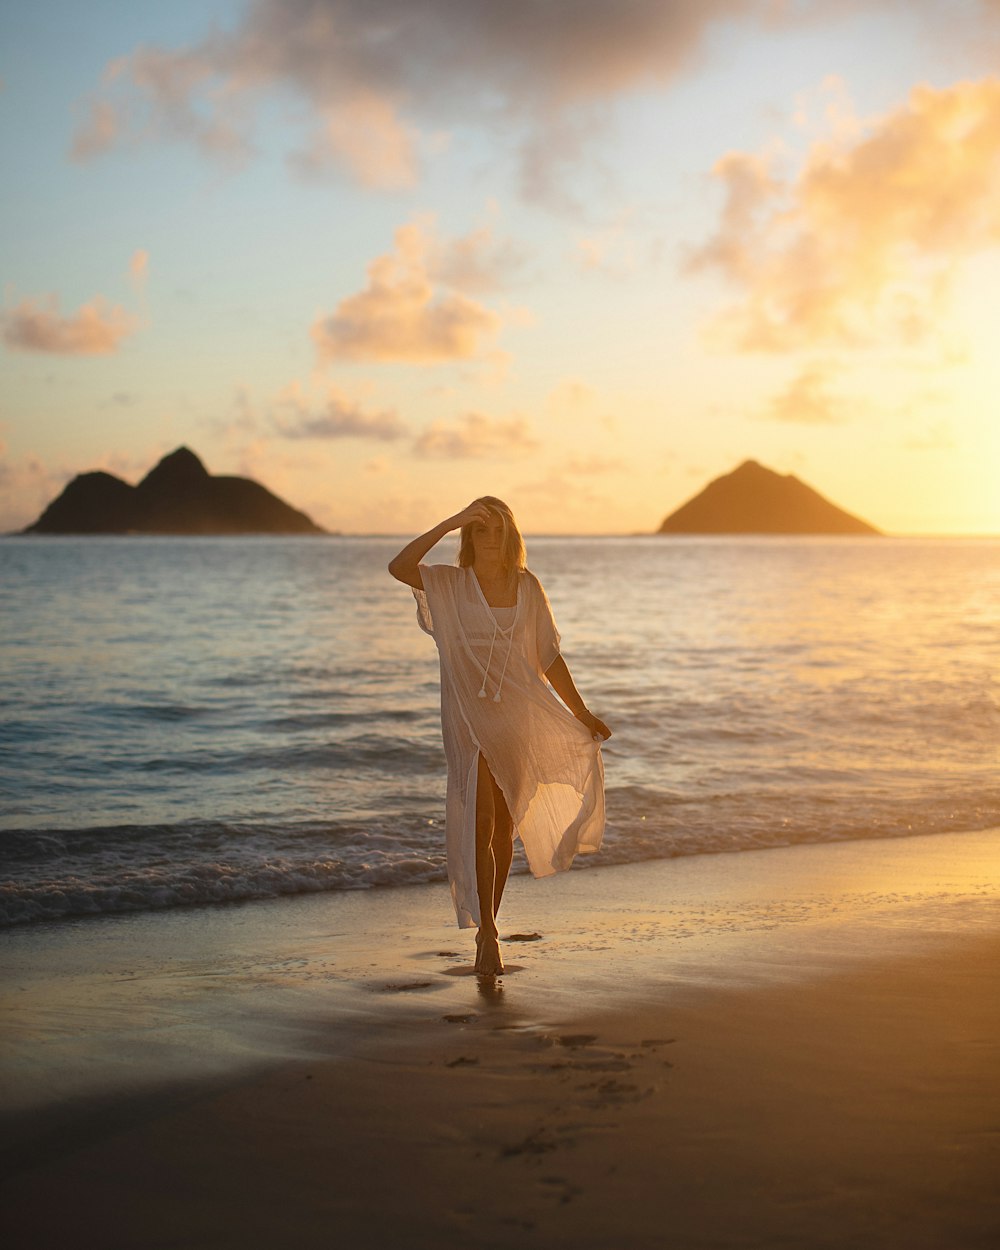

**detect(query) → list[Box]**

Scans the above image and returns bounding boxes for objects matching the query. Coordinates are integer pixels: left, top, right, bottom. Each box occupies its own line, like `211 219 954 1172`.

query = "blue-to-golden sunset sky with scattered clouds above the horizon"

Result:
0 0 1000 534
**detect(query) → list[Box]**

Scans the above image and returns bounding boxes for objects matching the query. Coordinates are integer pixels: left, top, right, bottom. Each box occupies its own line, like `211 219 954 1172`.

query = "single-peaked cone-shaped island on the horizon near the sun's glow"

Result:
656 460 879 534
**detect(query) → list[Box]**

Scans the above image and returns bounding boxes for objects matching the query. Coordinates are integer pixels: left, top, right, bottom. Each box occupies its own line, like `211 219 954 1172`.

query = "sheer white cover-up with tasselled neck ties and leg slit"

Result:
414 564 604 929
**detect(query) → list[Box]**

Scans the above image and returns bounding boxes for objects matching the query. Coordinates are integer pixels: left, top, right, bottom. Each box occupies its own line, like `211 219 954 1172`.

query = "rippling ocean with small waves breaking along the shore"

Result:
0 536 1000 925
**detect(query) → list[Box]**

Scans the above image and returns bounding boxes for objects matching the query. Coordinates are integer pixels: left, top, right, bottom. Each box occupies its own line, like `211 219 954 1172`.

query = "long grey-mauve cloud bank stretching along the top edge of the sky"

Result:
73 0 865 203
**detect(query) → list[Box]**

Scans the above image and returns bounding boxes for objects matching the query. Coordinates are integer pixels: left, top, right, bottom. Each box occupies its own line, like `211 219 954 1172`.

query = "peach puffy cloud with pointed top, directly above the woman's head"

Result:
311 221 500 365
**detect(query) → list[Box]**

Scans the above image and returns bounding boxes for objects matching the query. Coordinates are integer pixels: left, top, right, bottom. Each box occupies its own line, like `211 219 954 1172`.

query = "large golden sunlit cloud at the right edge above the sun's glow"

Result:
686 78 1000 353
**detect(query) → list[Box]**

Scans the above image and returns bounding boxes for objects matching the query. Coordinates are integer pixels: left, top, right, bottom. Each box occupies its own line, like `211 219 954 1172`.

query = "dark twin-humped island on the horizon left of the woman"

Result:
24 448 326 534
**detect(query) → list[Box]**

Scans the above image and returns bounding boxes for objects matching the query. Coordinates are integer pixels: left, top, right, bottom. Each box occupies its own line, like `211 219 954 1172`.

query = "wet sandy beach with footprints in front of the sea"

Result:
3 830 1000 1250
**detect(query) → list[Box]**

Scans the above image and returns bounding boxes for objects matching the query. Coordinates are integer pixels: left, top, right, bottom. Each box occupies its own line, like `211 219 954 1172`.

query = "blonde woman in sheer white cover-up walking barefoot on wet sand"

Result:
389 495 611 975
